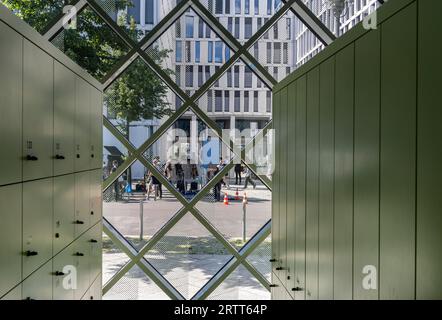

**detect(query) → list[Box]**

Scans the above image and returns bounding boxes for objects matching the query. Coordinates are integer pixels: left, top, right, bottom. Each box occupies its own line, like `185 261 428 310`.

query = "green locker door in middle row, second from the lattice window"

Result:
74 171 91 237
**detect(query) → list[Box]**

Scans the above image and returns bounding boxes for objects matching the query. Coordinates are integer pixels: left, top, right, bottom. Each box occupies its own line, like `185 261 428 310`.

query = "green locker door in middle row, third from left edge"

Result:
53 174 75 255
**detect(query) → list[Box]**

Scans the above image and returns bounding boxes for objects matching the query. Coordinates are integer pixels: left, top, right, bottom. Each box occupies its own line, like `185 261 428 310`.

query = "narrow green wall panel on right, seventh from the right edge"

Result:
290 76 307 300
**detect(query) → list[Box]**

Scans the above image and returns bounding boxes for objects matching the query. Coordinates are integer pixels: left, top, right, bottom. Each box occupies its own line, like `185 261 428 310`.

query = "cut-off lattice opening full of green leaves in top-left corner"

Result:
0 0 66 34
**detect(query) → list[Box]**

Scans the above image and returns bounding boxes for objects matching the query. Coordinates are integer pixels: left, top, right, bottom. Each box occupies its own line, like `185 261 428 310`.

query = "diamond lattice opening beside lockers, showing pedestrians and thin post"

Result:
103 161 182 249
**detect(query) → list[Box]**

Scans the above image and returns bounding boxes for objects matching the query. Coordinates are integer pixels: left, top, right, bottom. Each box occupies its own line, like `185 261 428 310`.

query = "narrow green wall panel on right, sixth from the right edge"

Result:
305 67 319 299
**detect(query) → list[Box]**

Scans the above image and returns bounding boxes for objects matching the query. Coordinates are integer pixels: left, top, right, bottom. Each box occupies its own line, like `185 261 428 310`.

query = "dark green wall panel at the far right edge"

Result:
416 1 442 299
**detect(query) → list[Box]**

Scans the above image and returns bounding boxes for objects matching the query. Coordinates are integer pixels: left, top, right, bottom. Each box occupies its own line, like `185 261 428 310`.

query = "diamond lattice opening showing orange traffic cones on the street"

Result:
196 163 272 248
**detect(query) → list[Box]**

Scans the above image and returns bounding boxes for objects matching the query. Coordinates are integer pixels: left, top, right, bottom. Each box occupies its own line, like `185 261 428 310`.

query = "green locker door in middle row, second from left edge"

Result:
23 178 52 277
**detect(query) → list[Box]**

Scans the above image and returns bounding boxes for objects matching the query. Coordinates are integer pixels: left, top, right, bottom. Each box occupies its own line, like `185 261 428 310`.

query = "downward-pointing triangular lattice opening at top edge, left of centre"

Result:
95 0 176 41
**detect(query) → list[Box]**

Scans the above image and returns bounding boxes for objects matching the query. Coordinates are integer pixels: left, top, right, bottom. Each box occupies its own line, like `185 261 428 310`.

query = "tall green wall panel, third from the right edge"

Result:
353 30 380 299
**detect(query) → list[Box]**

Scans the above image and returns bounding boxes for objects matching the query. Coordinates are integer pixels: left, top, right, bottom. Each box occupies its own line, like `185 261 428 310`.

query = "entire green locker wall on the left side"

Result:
0 21 102 299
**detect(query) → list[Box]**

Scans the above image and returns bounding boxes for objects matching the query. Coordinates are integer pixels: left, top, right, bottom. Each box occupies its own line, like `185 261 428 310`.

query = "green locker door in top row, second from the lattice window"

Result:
74 77 90 171
